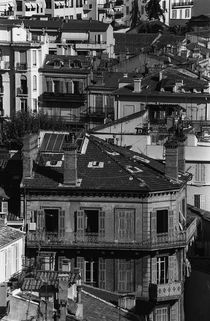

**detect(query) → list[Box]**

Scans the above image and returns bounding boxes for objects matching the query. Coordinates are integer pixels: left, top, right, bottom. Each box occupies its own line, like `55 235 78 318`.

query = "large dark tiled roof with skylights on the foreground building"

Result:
24 132 189 194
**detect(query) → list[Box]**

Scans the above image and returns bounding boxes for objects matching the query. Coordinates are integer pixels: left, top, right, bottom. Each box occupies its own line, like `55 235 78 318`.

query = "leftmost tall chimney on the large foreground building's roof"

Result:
22 134 38 178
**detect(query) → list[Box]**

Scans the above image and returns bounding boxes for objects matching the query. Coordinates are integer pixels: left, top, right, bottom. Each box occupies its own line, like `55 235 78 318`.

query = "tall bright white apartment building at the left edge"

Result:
0 20 48 116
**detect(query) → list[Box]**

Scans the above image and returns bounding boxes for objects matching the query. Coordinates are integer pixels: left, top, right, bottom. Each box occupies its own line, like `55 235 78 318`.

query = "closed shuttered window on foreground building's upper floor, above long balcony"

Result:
115 208 135 241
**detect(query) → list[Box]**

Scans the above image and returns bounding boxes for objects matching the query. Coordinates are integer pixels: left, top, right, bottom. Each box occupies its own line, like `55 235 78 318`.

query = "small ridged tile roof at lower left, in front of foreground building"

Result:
21 271 80 292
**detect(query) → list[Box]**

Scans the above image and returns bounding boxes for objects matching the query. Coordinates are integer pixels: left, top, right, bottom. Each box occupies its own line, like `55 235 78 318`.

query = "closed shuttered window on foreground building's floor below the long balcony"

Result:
117 259 134 292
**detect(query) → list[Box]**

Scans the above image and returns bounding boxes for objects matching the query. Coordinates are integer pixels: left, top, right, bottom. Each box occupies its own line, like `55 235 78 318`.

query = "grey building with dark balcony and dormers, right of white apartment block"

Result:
39 55 91 128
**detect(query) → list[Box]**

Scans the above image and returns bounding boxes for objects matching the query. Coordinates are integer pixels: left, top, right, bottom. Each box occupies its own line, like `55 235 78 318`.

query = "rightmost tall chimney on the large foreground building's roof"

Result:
164 138 178 180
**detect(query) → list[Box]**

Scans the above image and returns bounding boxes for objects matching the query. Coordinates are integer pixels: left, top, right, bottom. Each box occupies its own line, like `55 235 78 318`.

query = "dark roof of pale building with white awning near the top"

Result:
62 20 109 32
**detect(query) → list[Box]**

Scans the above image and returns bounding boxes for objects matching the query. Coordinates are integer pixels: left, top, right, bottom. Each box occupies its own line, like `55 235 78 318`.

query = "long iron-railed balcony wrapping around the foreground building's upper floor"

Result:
27 231 186 251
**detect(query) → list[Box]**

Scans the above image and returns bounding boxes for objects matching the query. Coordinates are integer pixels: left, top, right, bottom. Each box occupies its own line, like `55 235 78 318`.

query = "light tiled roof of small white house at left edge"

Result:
0 224 24 248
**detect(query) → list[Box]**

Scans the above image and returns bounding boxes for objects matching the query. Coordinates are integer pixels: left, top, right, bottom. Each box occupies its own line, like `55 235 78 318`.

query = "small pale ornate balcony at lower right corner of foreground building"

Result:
149 281 183 302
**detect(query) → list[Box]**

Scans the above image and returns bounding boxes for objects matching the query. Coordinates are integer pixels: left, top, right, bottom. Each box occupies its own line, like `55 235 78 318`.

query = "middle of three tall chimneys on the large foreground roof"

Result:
63 137 77 186
